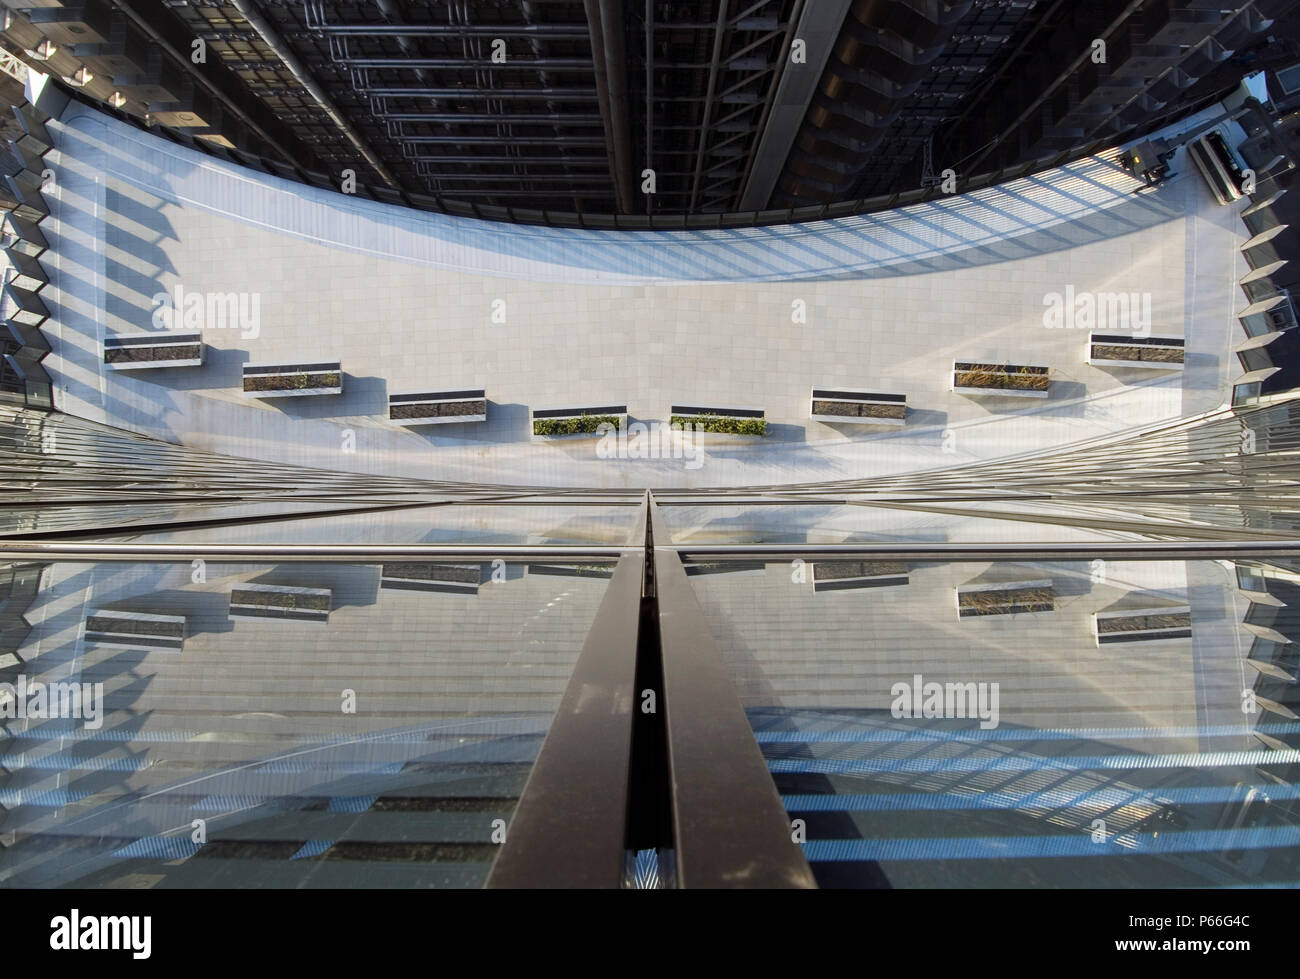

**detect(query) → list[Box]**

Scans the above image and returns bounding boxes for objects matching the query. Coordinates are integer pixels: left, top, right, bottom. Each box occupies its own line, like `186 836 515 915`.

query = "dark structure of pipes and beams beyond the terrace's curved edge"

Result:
0 0 1295 213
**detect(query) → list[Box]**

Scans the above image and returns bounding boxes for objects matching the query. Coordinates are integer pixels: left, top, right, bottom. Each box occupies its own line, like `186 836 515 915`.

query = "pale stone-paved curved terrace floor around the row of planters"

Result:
35 99 1244 486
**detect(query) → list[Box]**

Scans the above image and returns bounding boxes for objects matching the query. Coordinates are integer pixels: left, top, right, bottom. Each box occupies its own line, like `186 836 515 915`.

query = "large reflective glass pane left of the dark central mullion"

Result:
0 562 608 887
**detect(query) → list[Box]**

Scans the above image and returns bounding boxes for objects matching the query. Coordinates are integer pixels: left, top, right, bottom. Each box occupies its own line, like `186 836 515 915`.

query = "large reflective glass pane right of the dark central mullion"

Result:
692 562 1300 887
